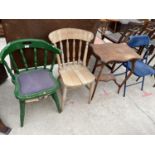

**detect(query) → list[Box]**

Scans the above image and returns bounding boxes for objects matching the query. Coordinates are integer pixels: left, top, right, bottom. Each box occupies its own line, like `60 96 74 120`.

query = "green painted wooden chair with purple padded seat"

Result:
0 39 62 127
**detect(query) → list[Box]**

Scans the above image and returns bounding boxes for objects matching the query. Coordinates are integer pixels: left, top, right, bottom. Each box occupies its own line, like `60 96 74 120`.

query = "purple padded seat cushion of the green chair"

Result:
18 69 55 95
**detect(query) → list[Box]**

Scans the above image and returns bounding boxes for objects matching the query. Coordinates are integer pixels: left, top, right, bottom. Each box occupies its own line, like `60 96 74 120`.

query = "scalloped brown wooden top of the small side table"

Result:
90 43 141 64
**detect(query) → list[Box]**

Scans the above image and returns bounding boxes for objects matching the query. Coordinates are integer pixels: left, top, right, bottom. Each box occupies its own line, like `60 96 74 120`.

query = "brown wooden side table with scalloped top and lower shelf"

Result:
91 43 141 98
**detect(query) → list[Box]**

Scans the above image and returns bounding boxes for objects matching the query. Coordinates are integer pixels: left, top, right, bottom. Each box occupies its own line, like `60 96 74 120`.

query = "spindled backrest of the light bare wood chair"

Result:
48 28 94 68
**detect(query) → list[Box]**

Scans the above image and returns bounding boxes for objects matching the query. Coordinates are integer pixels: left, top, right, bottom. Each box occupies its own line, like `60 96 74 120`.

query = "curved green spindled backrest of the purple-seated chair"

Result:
0 39 61 80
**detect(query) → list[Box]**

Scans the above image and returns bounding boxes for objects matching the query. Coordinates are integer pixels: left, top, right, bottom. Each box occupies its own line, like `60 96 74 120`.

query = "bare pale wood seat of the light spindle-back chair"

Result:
59 64 95 87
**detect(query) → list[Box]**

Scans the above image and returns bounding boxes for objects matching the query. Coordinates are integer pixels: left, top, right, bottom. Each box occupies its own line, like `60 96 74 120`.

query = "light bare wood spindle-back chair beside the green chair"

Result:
49 28 95 107
